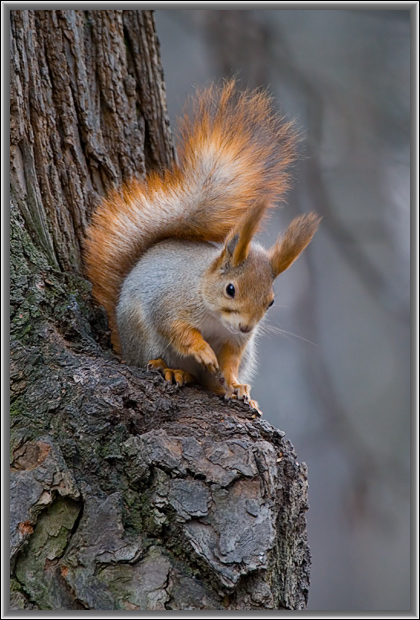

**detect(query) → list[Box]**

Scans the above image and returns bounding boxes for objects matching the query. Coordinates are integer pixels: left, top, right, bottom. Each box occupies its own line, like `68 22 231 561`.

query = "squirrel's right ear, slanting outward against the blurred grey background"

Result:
268 212 321 278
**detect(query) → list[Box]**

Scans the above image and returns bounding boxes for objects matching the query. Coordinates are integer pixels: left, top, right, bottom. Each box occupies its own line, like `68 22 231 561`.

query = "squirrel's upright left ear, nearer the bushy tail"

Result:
223 201 267 267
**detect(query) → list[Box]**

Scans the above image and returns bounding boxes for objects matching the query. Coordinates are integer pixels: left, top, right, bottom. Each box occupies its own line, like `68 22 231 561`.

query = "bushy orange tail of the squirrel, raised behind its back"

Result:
85 80 297 349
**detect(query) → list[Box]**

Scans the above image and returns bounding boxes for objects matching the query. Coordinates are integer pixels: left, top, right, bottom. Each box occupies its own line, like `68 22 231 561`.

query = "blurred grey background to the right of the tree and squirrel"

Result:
155 9 410 611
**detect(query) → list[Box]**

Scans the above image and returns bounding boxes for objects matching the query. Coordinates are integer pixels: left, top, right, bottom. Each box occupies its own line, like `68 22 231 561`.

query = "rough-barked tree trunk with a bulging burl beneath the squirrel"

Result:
10 11 310 610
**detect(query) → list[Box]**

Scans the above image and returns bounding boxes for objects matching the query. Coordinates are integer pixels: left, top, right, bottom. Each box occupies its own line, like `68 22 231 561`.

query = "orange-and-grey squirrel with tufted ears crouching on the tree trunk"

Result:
84 80 320 413
